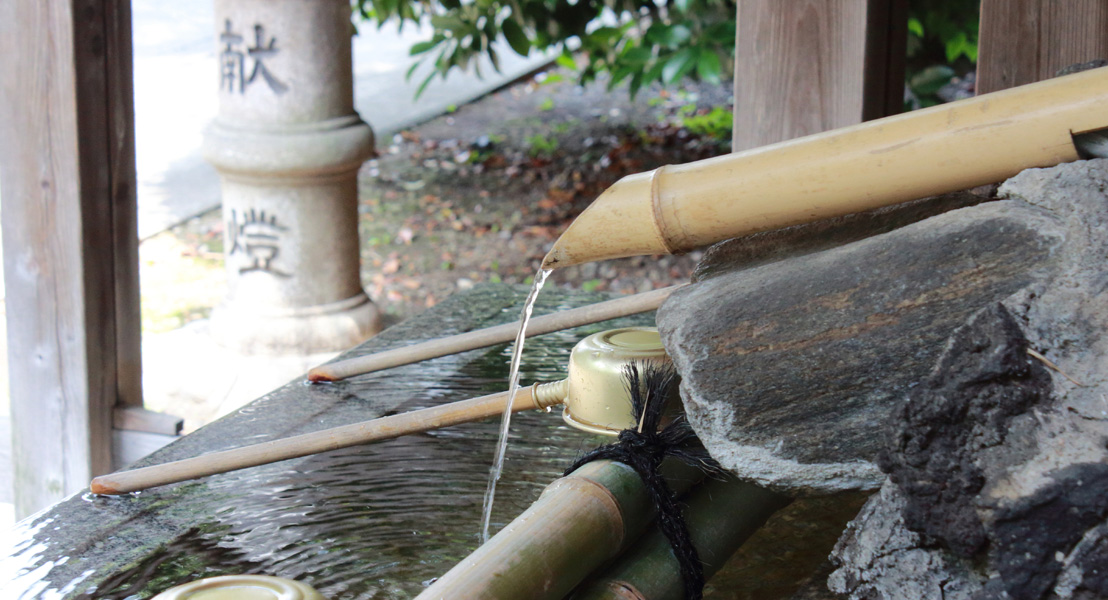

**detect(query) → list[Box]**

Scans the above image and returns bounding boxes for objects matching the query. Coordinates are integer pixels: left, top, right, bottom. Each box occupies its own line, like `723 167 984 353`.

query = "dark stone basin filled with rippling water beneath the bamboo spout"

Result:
0 286 850 600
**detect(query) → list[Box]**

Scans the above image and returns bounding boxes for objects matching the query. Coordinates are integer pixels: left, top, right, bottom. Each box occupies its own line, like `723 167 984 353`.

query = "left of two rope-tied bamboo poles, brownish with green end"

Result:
416 461 702 600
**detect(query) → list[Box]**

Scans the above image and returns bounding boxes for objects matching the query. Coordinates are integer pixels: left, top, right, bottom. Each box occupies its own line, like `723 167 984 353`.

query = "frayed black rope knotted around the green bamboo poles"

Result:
564 363 722 600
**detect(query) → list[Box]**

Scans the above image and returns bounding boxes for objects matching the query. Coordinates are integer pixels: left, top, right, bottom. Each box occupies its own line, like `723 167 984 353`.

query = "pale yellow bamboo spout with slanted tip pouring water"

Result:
543 68 1108 269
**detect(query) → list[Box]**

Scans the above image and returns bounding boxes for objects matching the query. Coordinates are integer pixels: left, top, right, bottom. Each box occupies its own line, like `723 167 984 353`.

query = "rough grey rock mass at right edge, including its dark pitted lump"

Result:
831 161 1108 600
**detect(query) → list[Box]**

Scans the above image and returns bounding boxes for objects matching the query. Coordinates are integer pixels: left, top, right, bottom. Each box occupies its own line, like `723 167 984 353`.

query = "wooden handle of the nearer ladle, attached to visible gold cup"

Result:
90 381 565 494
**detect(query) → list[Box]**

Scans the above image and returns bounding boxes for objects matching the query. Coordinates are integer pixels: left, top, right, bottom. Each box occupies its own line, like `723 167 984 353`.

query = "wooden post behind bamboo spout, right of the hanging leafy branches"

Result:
732 0 907 152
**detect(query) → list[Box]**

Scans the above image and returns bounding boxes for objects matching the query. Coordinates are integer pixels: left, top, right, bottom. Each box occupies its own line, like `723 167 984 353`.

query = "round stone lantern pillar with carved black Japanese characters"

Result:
204 0 379 354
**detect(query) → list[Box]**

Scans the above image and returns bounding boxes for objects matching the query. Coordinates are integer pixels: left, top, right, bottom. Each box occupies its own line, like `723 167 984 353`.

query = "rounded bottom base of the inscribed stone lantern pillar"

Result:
211 293 381 354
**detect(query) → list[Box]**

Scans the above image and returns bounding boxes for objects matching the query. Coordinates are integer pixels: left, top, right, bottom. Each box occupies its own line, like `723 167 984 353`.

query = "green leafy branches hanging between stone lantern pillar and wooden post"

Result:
355 0 735 95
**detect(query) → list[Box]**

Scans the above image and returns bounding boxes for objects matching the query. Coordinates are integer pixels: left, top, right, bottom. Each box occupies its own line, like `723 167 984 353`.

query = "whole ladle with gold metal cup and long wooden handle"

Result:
90 328 668 495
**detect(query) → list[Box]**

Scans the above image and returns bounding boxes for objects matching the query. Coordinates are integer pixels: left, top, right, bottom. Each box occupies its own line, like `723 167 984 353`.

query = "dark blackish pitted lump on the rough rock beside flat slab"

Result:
878 303 1050 558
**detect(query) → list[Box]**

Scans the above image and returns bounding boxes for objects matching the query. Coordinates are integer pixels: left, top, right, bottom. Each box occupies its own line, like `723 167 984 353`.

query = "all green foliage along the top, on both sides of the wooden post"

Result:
353 0 979 108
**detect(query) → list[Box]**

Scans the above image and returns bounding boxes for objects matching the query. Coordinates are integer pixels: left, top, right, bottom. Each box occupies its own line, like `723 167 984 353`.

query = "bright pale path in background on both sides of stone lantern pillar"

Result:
132 0 550 239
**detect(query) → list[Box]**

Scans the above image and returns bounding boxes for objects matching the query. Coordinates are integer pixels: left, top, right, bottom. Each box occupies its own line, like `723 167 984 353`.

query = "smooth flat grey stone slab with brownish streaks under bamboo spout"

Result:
658 200 1060 495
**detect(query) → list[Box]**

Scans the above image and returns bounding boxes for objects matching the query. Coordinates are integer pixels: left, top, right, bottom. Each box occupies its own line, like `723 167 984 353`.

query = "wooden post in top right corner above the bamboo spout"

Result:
977 0 1108 94
